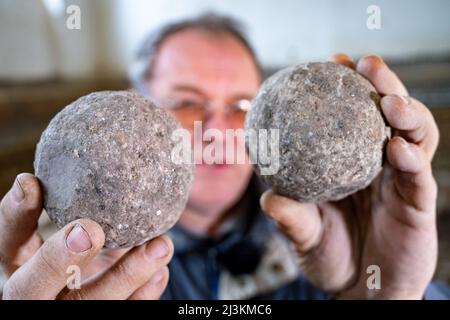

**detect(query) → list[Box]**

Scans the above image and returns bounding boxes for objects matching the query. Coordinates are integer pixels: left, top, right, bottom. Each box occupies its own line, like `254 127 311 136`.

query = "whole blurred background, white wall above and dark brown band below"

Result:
0 0 450 283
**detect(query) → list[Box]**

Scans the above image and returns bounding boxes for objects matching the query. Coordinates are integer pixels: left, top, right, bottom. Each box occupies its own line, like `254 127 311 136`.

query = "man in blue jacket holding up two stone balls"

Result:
0 15 450 299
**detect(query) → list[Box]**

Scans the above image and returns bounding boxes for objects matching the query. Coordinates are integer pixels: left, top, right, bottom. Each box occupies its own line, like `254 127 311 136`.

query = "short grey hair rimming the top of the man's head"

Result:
128 13 261 96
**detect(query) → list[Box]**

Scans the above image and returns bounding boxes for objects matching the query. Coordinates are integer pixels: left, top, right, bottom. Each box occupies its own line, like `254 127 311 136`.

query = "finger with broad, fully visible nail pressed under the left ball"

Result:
3 219 105 300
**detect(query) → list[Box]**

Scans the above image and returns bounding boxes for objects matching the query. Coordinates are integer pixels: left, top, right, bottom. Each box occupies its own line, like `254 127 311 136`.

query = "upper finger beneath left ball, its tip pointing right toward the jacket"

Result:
65 236 173 300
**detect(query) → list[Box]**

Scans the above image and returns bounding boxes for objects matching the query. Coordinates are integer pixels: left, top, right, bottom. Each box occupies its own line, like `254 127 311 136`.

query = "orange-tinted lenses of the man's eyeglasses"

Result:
159 99 251 129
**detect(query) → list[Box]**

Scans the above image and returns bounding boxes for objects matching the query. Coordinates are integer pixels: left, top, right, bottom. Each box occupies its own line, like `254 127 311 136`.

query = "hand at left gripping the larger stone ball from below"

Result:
0 174 173 299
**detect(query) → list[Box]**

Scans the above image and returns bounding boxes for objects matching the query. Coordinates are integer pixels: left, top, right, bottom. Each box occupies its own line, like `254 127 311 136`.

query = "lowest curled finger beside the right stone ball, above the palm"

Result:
387 137 437 212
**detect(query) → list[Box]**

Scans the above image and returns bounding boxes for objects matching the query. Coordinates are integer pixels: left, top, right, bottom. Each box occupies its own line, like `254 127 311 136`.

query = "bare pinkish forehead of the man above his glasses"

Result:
149 30 259 94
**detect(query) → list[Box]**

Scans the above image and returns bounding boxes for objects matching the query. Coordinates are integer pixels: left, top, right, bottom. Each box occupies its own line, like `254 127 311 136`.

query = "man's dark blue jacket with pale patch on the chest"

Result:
162 177 450 299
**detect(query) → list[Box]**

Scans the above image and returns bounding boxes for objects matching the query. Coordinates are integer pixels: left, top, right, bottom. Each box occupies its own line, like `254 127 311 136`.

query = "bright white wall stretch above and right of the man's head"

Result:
115 0 450 66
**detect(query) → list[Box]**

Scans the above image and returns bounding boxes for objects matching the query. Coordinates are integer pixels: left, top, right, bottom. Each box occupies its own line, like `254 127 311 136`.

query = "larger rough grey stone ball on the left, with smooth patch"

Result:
34 91 193 248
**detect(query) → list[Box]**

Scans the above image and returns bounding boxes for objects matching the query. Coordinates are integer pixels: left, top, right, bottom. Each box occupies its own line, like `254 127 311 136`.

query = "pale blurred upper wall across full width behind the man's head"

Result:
0 0 450 78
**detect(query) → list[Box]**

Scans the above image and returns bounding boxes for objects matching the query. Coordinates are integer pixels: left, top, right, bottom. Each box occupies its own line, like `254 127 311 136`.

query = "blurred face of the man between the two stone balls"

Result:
149 29 260 212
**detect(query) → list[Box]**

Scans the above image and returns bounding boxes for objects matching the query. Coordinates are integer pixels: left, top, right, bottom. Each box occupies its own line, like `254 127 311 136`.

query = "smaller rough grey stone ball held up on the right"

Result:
245 62 390 202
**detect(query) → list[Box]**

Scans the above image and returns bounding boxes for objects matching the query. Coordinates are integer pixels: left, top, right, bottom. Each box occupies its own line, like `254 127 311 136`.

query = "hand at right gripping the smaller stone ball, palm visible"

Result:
261 55 439 299
